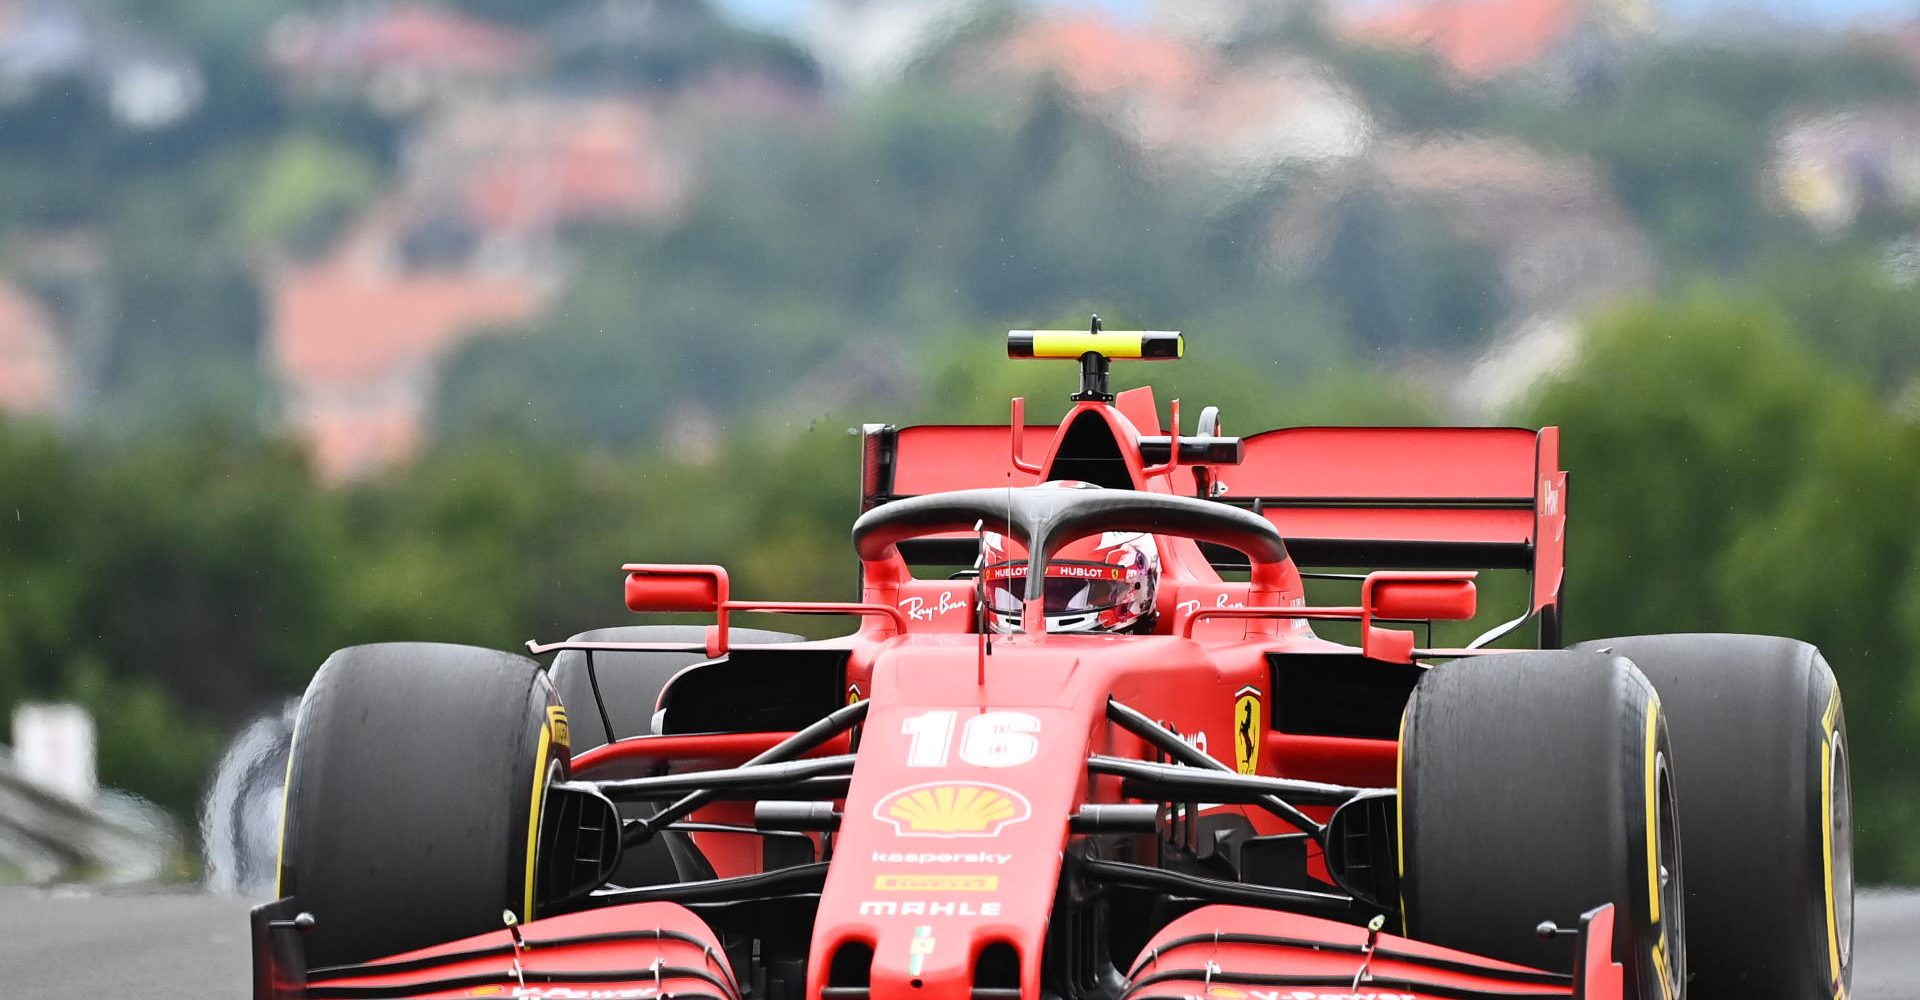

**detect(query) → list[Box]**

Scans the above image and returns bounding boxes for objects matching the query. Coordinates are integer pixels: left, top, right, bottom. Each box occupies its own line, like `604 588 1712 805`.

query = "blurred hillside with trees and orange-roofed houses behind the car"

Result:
0 0 1920 881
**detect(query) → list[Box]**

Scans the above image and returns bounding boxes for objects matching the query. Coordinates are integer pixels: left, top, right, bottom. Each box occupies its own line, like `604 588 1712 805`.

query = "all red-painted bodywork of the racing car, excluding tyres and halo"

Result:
266 381 1589 1000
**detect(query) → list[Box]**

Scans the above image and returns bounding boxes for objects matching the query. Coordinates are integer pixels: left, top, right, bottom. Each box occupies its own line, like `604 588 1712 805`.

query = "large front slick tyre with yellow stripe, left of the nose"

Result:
278 643 568 965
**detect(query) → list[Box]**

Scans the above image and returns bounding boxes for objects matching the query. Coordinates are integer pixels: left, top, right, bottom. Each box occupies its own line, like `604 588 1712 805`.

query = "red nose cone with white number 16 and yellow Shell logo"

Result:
808 643 1100 1000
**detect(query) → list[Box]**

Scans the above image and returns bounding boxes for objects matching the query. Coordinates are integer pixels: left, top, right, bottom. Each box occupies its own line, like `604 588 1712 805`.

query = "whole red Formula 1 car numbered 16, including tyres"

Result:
253 324 1853 1000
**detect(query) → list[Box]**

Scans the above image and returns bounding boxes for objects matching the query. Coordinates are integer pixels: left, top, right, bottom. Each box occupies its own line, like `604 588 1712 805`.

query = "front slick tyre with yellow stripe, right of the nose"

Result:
1400 651 1688 1000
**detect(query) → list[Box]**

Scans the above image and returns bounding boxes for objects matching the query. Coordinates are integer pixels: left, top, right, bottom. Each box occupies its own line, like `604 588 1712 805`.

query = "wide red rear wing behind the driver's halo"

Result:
860 418 1567 647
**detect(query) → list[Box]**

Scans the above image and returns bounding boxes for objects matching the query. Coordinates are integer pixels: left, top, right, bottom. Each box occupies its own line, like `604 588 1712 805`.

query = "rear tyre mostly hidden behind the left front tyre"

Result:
553 626 801 752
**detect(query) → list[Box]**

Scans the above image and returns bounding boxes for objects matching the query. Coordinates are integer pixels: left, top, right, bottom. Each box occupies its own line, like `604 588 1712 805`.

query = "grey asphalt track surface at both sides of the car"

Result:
0 891 1920 1000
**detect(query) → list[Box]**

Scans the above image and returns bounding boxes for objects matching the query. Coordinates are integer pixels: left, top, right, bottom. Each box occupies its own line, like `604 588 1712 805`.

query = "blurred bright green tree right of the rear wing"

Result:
1524 292 1920 881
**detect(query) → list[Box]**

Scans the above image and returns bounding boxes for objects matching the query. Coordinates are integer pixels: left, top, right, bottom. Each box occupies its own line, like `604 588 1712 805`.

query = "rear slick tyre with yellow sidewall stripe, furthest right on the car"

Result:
1578 635 1853 1000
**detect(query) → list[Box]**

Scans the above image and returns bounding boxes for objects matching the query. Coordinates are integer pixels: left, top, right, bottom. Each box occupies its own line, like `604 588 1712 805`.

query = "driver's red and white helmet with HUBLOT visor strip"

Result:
979 480 1160 633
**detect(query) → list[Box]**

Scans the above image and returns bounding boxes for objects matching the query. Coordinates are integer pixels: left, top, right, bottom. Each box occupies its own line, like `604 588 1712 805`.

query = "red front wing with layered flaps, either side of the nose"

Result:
253 900 1622 1000
